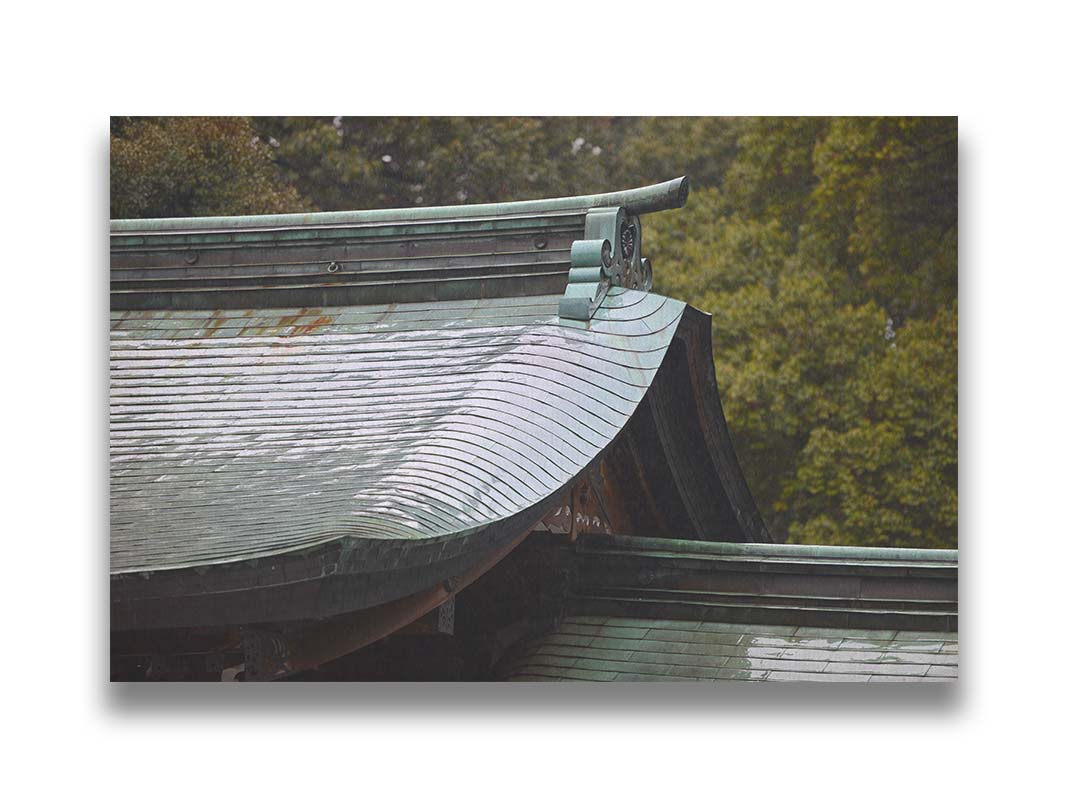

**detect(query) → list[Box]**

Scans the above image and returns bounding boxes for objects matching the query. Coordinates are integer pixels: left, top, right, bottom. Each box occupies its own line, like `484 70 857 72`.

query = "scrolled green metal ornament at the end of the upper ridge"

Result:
559 207 652 321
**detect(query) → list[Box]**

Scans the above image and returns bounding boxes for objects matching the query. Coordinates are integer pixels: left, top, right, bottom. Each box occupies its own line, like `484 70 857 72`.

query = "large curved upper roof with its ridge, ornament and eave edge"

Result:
111 178 764 627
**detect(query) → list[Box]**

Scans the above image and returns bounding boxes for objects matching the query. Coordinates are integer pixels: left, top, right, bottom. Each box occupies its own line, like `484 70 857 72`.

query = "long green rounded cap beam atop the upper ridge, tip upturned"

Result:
111 176 689 234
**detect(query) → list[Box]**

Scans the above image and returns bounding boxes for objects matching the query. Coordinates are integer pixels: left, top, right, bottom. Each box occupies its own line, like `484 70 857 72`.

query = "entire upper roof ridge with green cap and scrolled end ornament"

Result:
111 178 689 320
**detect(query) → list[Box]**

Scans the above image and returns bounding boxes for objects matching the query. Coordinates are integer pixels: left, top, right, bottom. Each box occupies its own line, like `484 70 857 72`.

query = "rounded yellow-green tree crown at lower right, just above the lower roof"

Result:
783 303 958 547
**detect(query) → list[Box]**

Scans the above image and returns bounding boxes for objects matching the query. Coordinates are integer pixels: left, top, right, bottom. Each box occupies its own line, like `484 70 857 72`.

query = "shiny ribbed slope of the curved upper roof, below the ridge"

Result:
111 289 685 574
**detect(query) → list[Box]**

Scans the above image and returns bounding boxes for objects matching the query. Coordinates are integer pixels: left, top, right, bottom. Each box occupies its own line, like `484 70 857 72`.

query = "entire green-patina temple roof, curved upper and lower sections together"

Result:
110 178 958 682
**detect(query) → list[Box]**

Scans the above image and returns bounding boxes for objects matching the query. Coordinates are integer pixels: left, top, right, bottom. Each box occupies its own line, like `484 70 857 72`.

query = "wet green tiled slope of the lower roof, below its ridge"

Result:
500 617 959 683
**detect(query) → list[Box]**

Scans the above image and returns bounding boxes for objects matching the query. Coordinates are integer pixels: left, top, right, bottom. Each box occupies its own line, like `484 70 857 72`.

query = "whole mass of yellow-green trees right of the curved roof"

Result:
647 118 957 546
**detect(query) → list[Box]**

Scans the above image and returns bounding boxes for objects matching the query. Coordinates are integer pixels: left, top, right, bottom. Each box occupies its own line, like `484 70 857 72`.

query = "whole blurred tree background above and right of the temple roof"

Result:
111 117 958 547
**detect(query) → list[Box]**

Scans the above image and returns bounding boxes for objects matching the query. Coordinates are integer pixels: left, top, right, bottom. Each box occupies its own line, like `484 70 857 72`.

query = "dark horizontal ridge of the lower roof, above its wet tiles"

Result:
569 537 958 631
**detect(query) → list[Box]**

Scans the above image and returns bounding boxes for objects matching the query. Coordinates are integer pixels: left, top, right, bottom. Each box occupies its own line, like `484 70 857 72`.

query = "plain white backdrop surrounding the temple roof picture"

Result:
0 0 1067 800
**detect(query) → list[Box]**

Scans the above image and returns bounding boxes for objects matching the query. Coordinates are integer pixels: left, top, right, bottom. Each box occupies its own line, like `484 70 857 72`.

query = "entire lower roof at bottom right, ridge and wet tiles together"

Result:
499 537 959 683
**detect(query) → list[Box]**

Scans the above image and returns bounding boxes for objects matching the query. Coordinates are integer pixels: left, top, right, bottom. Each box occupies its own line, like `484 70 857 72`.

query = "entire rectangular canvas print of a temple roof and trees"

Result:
109 116 959 683
